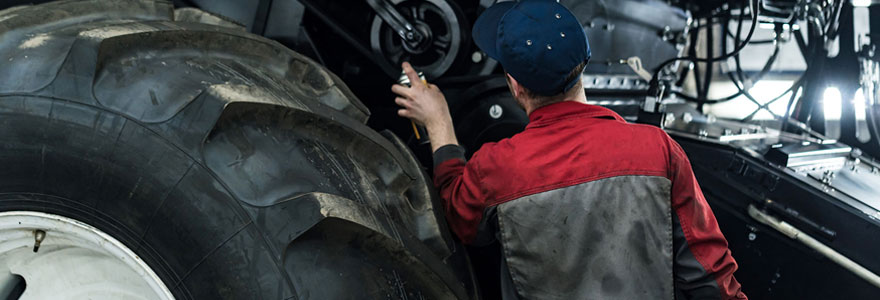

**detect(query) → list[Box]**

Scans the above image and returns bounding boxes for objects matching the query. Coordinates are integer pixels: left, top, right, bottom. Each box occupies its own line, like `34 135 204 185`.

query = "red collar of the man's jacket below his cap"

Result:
526 101 624 128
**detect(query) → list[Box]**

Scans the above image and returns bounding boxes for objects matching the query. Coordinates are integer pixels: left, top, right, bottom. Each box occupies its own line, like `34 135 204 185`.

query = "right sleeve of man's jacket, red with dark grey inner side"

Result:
667 137 747 299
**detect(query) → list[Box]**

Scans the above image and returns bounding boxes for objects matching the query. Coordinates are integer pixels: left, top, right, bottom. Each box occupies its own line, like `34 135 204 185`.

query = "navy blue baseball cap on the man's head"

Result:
473 0 590 96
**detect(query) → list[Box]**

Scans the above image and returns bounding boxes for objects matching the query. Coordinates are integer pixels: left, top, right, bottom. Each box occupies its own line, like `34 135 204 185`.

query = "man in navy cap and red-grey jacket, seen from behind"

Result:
392 0 746 299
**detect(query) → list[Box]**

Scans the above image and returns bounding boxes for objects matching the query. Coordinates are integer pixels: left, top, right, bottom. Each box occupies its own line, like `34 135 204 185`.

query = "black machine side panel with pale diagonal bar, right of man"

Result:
673 134 880 299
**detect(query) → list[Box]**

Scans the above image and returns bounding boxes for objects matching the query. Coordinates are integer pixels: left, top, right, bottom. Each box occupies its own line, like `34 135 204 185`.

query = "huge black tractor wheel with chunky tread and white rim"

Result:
0 0 477 299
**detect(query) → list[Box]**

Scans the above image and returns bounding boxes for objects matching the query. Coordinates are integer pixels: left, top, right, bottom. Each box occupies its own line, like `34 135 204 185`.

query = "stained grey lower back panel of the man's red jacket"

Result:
497 176 674 299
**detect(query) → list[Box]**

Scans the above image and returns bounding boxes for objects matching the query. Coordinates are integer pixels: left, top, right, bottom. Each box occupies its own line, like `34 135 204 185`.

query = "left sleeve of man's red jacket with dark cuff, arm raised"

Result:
434 145 486 244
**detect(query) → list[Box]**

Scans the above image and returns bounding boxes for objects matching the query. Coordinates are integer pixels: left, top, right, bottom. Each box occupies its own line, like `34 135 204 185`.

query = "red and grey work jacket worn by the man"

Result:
434 101 746 299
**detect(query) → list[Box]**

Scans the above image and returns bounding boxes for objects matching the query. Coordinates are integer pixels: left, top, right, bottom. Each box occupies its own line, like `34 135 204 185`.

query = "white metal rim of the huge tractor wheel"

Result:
0 211 174 299
